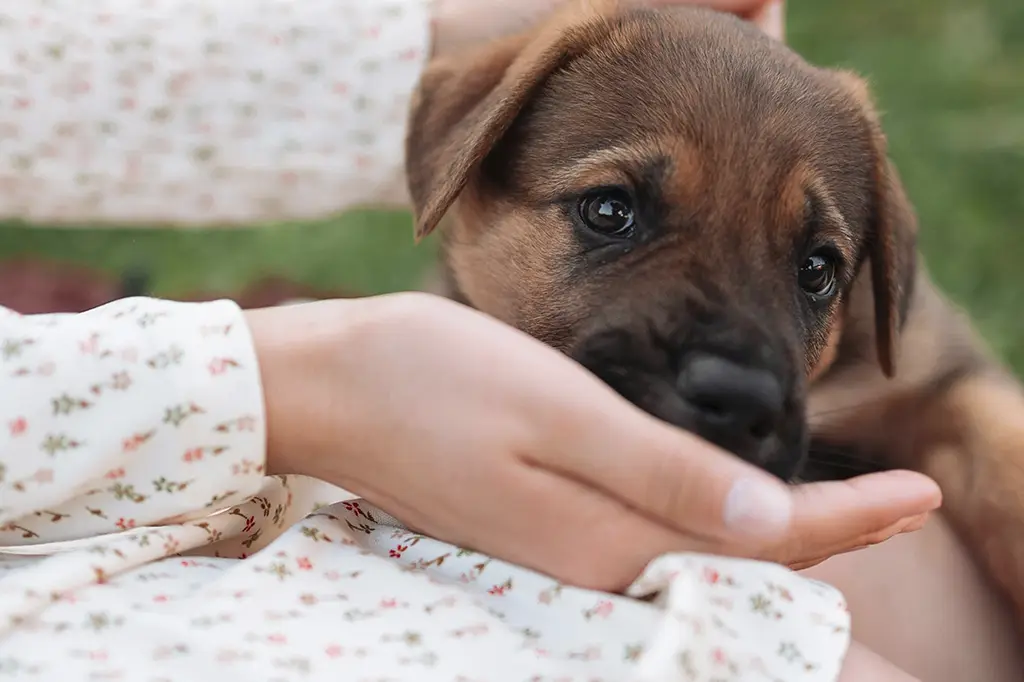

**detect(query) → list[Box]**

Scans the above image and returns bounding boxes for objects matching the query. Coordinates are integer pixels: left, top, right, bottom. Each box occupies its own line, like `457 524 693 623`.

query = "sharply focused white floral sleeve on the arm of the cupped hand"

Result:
0 298 266 546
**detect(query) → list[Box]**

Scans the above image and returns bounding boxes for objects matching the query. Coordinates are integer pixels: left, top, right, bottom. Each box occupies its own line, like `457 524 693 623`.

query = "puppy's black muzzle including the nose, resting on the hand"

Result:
568 315 807 480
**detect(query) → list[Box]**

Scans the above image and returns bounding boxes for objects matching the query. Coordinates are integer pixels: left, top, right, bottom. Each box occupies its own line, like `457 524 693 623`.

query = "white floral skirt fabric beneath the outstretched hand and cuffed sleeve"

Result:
0 491 851 682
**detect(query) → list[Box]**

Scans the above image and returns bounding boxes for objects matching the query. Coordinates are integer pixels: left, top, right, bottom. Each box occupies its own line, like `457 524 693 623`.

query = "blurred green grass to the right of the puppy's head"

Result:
790 0 1024 375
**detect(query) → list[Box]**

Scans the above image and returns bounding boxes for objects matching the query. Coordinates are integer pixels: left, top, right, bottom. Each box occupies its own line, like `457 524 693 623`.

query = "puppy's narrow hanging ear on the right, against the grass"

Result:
837 72 918 377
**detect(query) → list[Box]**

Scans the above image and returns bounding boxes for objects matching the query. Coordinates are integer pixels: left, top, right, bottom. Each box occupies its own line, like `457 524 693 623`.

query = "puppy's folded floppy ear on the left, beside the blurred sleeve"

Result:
406 0 617 240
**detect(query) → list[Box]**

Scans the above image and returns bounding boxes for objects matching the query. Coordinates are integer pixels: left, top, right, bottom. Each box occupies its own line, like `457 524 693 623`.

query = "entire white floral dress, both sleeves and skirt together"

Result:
0 0 849 682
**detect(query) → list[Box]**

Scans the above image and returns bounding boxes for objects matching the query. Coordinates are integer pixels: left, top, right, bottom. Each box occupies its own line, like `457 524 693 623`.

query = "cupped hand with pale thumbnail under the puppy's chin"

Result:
248 294 939 591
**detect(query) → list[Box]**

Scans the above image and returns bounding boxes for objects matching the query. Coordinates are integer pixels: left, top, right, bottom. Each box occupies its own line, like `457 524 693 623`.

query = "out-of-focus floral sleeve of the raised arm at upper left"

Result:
0 0 430 226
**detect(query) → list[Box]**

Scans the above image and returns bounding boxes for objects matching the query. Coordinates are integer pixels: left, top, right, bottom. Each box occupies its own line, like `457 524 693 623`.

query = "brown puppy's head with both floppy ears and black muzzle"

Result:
407 0 915 478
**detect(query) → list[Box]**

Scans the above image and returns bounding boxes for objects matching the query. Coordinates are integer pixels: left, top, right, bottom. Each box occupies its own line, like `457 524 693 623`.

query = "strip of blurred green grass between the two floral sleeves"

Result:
0 211 434 296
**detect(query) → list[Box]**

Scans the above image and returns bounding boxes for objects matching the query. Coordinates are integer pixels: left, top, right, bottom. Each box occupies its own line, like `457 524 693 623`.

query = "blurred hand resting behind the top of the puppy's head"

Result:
434 0 784 54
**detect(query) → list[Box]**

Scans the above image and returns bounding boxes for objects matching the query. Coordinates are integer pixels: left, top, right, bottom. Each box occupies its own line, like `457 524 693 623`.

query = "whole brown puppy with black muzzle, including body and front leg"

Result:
407 1 1024 630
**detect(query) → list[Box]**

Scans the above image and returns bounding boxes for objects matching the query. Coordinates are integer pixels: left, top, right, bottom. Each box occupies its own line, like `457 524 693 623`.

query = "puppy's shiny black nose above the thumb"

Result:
676 353 784 454
